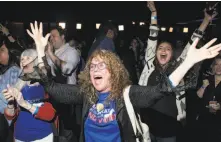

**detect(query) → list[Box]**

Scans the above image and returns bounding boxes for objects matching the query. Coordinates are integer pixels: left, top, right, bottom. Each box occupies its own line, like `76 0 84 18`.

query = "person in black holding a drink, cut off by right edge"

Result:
197 56 221 142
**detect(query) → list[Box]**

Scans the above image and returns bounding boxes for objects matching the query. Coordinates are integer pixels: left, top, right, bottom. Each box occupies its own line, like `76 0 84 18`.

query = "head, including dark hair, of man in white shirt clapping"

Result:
50 26 65 49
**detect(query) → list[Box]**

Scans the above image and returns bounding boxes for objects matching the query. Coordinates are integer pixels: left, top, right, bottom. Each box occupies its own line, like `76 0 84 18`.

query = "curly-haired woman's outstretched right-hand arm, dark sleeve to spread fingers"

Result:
129 39 221 108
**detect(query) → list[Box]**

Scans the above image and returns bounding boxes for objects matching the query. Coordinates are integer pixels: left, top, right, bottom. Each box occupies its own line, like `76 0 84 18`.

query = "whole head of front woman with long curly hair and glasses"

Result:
79 50 130 102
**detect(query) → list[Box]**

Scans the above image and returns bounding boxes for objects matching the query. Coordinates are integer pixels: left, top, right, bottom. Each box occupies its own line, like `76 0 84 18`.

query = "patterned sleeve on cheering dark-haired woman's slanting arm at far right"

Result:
177 30 203 61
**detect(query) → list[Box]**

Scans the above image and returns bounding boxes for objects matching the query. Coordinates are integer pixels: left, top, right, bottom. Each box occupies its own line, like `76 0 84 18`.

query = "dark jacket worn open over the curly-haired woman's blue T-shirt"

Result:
37 67 173 142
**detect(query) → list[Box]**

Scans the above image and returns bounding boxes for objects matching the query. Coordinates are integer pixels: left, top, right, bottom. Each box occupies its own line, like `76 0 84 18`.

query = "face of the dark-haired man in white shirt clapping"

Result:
50 29 64 49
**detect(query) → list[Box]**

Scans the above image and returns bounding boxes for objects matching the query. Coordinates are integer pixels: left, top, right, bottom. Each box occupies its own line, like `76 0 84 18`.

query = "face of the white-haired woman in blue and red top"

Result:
20 56 34 73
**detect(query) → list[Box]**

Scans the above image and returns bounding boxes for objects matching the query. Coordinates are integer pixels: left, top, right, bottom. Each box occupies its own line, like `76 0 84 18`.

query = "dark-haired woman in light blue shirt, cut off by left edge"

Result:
0 36 23 141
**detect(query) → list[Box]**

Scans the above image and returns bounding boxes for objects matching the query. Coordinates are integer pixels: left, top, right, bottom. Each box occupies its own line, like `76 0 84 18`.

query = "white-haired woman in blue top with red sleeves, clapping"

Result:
2 49 56 142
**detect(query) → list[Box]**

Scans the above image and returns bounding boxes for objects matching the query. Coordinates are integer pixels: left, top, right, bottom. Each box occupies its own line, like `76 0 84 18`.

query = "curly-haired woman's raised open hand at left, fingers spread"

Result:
27 21 50 55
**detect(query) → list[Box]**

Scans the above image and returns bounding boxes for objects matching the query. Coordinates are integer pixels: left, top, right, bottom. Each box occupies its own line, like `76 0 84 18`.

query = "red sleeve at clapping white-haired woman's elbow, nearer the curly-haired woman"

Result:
35 102 56 121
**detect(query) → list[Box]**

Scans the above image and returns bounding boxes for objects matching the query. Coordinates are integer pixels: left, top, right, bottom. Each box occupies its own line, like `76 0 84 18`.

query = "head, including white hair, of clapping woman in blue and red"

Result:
20 49 38 74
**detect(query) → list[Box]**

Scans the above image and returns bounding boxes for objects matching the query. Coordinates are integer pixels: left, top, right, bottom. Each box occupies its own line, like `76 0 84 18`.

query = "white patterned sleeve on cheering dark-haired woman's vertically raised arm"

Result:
145 25 159 63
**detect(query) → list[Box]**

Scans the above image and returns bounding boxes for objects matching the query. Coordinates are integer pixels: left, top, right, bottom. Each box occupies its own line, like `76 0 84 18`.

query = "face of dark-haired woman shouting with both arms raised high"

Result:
156 43 172 65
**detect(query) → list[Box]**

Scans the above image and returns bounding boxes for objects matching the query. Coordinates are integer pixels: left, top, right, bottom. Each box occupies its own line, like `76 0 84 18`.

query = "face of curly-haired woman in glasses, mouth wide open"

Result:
90 57 111 93
